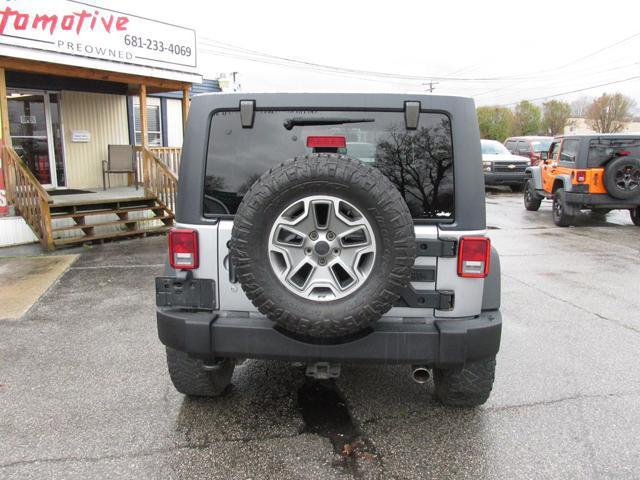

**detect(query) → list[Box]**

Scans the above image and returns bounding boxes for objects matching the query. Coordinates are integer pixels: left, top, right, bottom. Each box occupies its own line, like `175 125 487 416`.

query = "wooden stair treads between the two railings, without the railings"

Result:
49 196 174 248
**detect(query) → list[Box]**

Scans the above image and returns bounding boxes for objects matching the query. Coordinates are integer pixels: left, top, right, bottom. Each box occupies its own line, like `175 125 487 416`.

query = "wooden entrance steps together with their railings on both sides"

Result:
0 144 179 250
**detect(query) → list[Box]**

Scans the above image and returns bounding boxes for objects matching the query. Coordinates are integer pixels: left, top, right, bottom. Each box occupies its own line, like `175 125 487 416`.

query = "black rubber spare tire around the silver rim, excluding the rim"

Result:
230 154 416 339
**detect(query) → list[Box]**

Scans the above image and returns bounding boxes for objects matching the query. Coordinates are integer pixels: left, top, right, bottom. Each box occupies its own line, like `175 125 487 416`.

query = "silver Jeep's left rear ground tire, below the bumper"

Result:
167 347 235 397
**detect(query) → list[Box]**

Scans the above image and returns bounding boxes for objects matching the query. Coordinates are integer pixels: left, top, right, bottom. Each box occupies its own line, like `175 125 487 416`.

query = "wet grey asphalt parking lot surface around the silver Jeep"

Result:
0 194 640 479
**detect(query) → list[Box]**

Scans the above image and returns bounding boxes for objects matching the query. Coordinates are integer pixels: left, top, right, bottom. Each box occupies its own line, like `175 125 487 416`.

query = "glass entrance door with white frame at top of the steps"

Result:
7 89 65 188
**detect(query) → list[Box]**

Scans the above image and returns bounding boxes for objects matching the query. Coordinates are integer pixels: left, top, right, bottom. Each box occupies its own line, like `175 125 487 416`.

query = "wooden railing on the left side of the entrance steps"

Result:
2 144 53 250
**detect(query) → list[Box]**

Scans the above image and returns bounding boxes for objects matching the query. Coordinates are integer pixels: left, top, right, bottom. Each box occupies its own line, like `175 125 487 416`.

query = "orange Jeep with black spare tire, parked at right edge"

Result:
524 133 640 227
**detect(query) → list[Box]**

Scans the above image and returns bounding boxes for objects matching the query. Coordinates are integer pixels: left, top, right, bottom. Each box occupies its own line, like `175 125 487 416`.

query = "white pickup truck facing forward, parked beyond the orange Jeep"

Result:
480 140 529 190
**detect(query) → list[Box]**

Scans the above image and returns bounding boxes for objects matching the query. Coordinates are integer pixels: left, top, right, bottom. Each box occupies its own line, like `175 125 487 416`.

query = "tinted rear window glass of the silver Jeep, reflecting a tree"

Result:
203 110 454 220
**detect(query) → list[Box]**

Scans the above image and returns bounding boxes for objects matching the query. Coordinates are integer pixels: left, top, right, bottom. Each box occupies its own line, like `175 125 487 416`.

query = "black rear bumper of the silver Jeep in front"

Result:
157 309 502 367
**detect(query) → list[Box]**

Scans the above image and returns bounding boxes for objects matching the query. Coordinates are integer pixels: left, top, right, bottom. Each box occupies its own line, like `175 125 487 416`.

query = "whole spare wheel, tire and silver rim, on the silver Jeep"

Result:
231 154 416 338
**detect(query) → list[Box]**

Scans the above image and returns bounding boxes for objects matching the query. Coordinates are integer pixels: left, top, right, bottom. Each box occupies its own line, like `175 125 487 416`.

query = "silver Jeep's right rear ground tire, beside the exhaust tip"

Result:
433 357 496 407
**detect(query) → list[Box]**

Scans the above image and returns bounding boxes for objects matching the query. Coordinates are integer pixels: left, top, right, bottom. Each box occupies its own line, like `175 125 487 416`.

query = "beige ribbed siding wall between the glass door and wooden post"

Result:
62 91 129 188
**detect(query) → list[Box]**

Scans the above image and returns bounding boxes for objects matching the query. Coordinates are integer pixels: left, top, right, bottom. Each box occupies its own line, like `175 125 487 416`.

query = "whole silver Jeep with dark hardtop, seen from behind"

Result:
156 93 502 406
